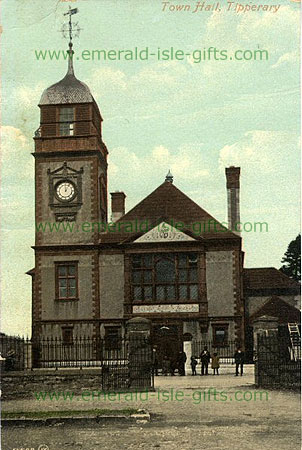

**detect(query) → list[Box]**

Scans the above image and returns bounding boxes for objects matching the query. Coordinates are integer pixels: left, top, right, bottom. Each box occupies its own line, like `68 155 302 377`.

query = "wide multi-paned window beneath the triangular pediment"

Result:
131 253 198 302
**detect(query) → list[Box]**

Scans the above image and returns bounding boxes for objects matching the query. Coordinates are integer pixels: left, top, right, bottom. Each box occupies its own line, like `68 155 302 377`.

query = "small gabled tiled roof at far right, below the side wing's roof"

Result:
250 295 301 323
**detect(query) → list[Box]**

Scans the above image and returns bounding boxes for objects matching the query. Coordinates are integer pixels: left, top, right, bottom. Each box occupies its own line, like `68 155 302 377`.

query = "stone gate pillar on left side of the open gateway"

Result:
126 317 153 389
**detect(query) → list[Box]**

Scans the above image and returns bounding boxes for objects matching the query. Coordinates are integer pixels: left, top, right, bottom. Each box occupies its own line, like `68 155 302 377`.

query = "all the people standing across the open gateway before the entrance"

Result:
154 347 244 376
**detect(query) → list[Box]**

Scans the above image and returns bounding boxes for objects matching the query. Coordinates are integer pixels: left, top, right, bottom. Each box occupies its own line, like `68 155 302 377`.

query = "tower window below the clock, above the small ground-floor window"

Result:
55 262 78 300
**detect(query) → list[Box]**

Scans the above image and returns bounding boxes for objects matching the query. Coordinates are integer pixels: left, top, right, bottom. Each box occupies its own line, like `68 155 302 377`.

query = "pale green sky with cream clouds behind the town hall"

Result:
1 0 300 334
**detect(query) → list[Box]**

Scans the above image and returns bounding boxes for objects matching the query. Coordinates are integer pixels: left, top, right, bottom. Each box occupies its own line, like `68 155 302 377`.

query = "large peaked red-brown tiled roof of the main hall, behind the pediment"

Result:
100 181 240 243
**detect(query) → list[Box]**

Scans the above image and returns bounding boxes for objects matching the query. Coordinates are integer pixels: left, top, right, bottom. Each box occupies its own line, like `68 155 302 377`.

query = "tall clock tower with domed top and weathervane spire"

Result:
30 20 108 340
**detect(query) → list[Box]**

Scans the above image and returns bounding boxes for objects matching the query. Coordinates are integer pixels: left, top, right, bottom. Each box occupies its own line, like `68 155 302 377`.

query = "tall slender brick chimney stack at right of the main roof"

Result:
225 166 241 234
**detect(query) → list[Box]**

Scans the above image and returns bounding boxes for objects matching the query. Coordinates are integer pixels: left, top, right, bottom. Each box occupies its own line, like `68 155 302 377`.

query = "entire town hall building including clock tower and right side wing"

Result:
28 37 300 364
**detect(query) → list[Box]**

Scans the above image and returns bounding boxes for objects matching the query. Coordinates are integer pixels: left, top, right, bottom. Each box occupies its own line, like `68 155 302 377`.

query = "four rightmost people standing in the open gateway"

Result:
191 347 244 376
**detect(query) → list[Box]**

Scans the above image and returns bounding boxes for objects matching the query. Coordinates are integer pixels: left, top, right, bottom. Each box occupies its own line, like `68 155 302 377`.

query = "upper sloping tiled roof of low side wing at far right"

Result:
243 267 300 289
